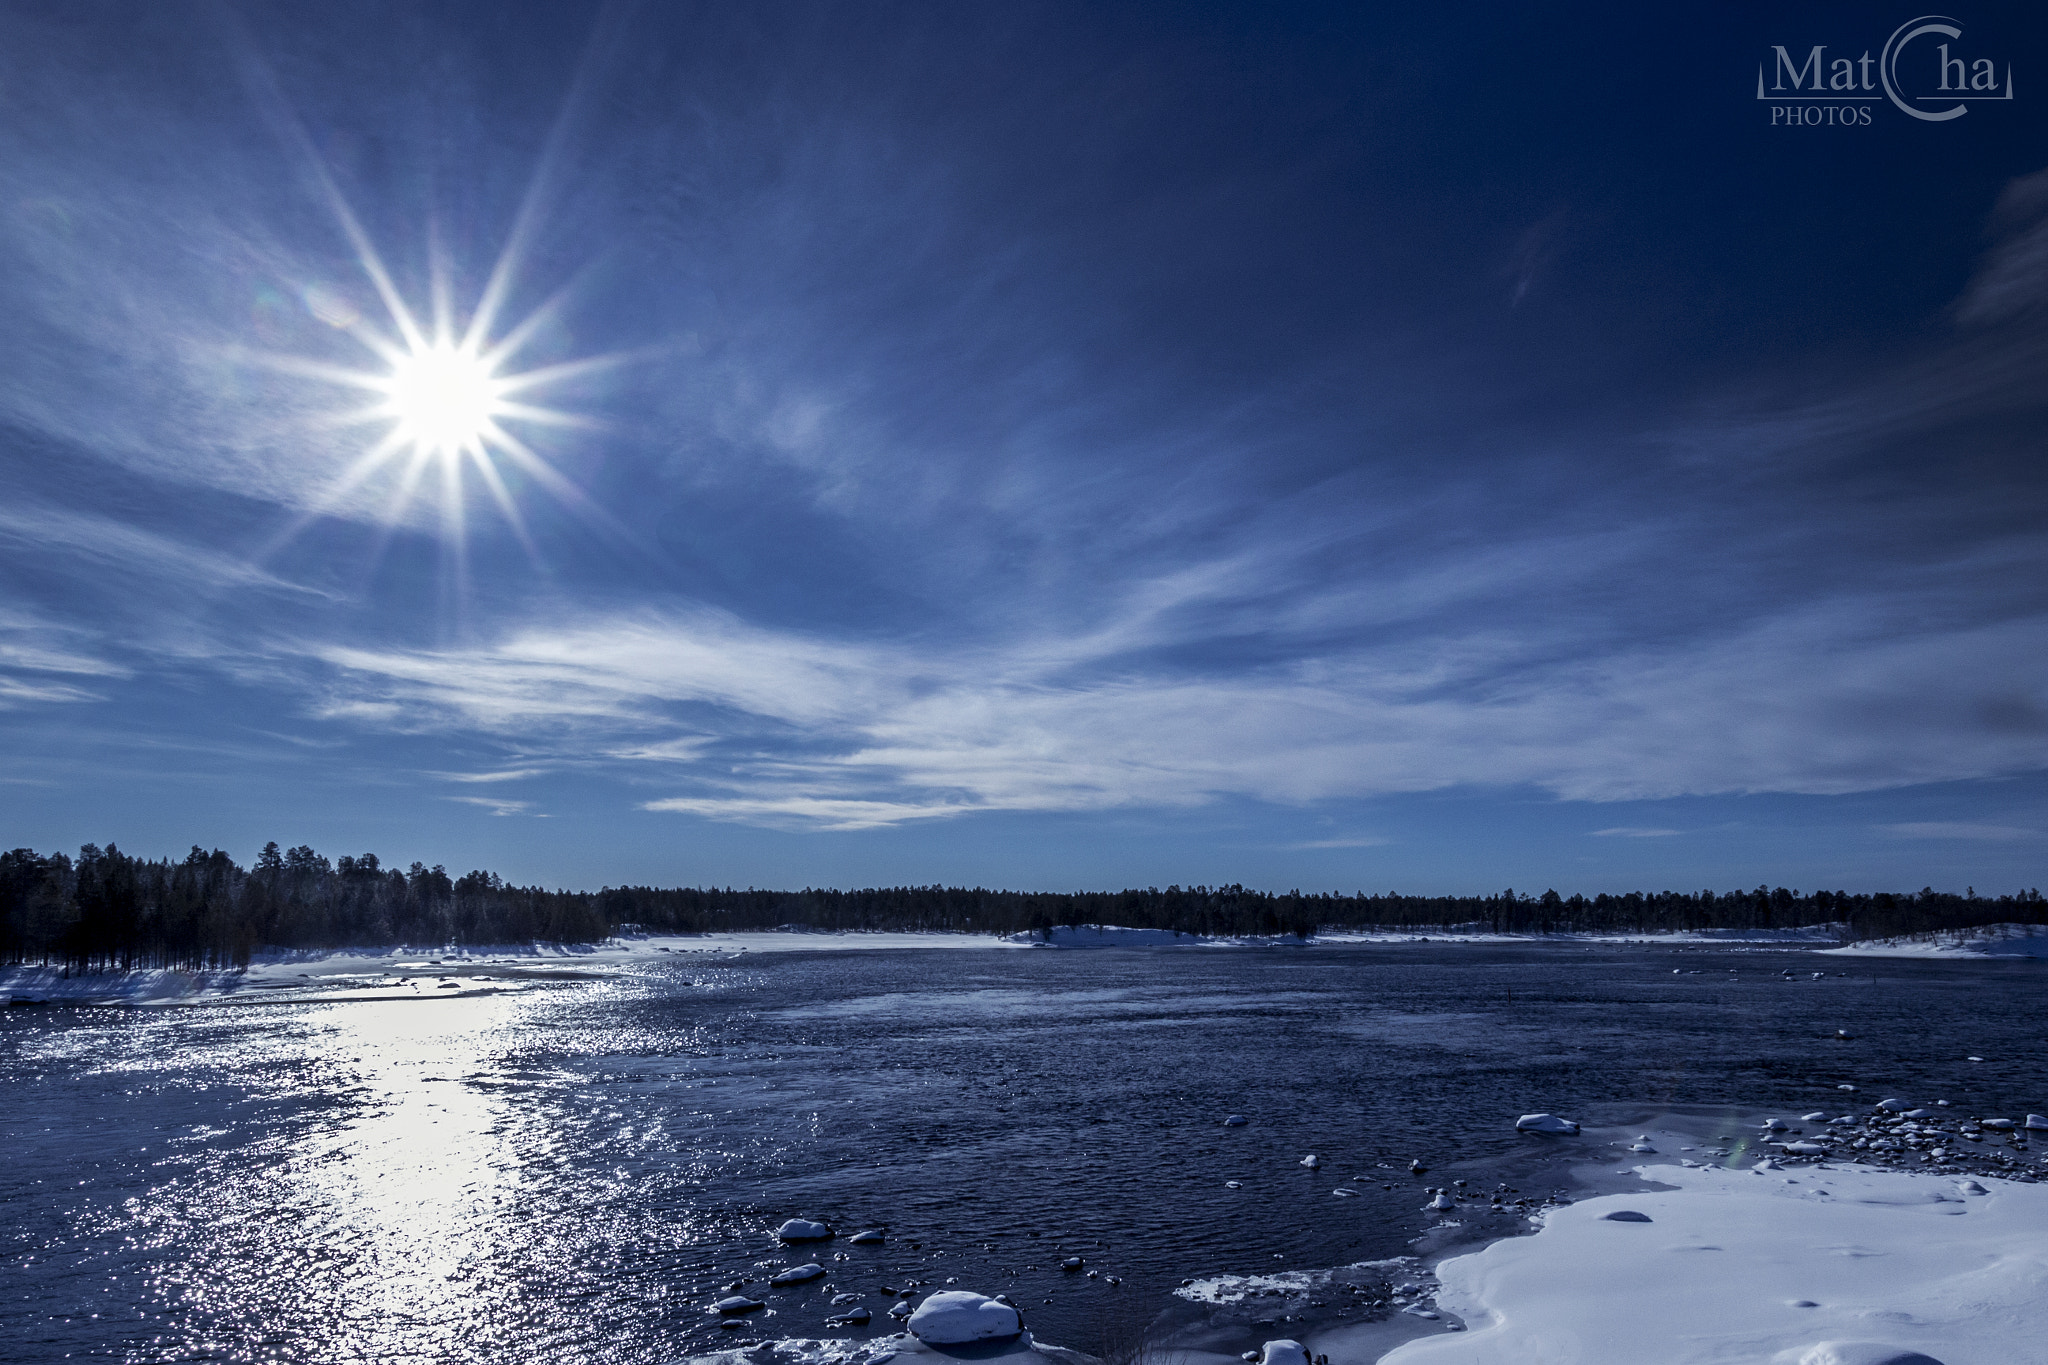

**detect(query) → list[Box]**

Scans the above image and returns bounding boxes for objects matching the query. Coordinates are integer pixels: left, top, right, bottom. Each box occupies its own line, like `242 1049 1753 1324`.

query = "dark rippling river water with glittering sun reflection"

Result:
0 945 2048 1363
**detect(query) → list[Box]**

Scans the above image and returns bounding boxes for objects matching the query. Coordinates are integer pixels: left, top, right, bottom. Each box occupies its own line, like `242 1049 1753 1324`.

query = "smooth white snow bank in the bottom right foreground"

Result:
1376 1164 2048 1365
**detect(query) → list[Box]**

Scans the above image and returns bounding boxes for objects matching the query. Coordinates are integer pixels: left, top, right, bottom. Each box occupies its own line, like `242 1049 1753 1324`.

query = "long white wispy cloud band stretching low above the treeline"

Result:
292 568 2048 837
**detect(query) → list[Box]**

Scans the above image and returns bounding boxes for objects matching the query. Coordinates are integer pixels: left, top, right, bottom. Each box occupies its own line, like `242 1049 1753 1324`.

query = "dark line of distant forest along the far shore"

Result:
0 843 2048 972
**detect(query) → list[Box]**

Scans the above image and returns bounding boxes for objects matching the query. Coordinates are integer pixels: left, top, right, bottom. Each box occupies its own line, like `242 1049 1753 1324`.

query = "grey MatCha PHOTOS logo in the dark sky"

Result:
1757 14 2013 127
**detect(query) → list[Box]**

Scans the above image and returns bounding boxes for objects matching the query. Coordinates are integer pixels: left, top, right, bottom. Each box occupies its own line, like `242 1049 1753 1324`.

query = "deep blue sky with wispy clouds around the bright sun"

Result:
0 2 2048 892
